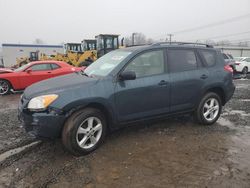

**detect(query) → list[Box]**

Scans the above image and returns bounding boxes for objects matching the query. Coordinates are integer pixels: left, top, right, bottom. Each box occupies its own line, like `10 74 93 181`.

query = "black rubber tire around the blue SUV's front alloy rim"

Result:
62 108 107 156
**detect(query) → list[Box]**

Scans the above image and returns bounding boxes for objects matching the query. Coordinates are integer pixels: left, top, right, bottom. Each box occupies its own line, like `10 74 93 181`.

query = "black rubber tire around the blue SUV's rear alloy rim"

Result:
194 92 222 125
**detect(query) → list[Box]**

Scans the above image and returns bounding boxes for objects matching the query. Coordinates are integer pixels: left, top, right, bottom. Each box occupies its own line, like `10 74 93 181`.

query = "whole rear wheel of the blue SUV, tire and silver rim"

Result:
195 92 222 125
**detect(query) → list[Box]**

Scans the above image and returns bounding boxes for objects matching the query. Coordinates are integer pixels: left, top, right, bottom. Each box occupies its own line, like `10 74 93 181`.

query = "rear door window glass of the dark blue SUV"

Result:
168 49 198 72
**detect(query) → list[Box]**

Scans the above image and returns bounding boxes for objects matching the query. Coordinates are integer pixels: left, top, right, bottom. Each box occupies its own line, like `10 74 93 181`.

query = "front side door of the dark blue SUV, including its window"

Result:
115 50 170 122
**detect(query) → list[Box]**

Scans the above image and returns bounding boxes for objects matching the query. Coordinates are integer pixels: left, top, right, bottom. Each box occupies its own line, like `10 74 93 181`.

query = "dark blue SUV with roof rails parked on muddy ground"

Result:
19 43 235 155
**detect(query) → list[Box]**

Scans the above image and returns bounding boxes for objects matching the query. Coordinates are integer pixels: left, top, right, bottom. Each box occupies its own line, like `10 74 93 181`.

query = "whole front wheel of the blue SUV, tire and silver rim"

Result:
62 108 107 156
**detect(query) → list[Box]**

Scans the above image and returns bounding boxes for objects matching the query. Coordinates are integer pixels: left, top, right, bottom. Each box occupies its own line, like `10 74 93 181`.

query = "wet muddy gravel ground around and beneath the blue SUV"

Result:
0 80 250 188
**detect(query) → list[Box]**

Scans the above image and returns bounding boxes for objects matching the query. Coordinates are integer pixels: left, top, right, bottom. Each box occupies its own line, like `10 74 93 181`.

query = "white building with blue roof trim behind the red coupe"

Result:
2 44 64 67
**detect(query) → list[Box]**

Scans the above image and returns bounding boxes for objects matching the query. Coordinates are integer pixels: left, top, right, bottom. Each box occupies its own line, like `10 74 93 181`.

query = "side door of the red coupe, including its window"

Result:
20 63 52 88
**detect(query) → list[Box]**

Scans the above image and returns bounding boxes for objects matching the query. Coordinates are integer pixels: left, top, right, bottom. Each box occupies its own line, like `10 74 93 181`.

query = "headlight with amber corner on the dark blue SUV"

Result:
28 94 58 111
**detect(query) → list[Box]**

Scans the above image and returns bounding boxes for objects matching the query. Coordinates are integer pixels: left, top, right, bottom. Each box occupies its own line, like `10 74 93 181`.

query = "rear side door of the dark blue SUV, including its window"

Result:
167 48 209 112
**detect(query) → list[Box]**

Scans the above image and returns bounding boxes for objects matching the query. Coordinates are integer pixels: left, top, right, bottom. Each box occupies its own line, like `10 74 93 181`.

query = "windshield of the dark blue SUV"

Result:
84 51 131 76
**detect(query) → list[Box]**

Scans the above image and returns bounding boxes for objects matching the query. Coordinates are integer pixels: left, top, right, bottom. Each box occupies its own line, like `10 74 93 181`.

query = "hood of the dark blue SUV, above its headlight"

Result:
24 73 98 99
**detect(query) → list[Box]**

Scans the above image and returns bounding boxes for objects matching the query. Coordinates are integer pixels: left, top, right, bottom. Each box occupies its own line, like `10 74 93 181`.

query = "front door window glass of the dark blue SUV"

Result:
124 50 164 78
